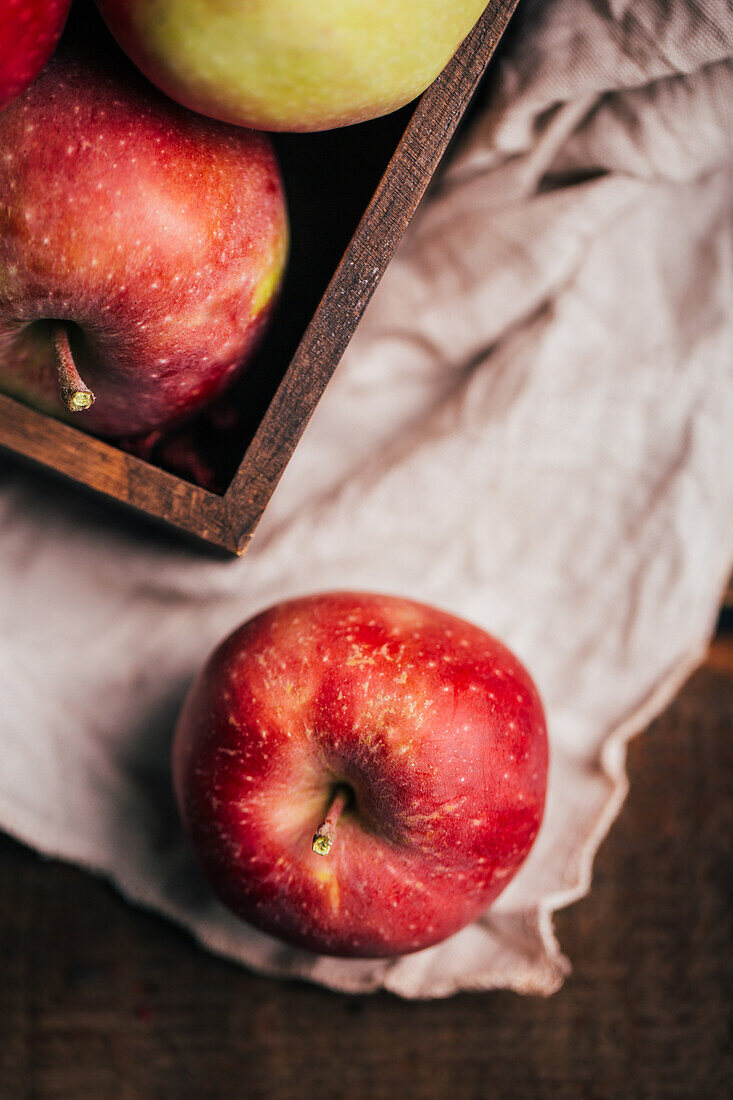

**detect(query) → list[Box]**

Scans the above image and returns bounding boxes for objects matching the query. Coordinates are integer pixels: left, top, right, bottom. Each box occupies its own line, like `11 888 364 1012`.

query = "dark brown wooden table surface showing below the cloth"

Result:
0 622 733 1100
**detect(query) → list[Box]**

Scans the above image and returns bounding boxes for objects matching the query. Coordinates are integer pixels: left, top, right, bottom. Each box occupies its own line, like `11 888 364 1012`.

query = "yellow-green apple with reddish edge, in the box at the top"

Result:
97 0 486 130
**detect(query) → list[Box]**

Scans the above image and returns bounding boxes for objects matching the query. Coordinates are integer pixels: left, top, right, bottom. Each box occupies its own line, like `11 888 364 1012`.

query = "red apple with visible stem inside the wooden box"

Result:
0 36 287 437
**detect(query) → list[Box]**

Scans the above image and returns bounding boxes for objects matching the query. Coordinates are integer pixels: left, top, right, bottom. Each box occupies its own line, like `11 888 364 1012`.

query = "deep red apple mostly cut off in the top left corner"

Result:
0 0 72 108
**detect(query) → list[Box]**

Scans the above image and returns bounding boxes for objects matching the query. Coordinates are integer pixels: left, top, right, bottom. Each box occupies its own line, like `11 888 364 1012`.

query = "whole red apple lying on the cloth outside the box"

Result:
173 593 547 957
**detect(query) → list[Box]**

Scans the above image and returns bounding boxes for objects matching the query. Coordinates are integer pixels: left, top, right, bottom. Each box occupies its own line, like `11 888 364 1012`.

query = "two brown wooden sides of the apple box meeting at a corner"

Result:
0 0 516 553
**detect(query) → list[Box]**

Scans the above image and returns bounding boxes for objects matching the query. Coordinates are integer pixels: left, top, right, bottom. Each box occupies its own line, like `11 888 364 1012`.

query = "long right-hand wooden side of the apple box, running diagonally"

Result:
225 0 517 553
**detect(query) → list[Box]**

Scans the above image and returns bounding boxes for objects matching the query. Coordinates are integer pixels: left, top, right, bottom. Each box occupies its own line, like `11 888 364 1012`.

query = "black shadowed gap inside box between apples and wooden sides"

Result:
117 103 416 494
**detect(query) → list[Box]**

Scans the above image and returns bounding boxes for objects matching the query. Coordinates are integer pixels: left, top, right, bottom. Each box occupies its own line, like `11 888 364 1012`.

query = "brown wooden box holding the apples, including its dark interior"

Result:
0 0 517 554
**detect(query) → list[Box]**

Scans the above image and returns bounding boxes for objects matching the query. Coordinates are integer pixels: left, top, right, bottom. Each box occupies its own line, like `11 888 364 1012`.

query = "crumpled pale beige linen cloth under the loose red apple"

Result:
0 0 733 997
